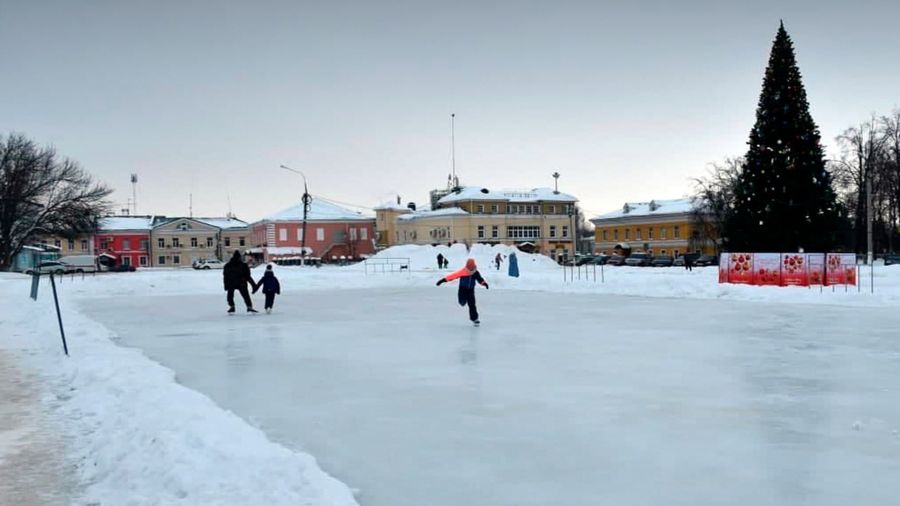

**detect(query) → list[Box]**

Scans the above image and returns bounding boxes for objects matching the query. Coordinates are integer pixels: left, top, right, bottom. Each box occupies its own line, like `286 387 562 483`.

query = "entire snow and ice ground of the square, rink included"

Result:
0 245 900 506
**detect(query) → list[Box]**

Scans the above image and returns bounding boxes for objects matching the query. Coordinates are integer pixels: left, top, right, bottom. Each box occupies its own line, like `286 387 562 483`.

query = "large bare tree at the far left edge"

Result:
0 134 112 270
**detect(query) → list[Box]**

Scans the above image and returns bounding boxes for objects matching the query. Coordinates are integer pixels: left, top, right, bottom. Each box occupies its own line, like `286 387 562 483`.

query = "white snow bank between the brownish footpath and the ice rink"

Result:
0 275 357 506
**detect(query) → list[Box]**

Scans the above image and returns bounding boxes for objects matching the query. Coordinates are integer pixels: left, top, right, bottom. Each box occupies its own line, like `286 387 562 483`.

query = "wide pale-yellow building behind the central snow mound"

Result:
375 186 577 258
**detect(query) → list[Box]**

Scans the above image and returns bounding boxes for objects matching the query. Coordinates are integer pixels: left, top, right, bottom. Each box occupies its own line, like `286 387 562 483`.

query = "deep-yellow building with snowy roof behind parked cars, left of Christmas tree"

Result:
591 198 716 257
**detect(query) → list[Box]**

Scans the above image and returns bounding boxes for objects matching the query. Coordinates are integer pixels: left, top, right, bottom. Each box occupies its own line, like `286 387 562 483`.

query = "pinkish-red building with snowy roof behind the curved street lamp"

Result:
249 197 375 262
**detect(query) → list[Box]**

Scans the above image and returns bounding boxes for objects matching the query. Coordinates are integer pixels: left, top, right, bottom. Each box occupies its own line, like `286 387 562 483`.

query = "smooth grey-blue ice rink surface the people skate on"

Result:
80 286 900 506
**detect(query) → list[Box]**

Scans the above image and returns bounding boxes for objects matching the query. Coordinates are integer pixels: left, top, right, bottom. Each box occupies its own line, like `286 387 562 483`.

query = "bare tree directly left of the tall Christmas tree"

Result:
688 157 744 251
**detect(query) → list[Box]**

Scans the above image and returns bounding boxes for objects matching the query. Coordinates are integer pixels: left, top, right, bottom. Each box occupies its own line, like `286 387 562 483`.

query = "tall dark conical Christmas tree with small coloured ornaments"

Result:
724 24 838 252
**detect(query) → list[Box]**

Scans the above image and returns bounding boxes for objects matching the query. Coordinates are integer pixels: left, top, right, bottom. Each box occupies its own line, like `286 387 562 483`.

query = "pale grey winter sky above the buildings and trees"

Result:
0 0 900 221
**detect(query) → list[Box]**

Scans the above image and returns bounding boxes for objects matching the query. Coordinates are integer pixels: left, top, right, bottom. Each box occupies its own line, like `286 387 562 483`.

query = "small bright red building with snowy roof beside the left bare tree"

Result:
94 216 157 267
